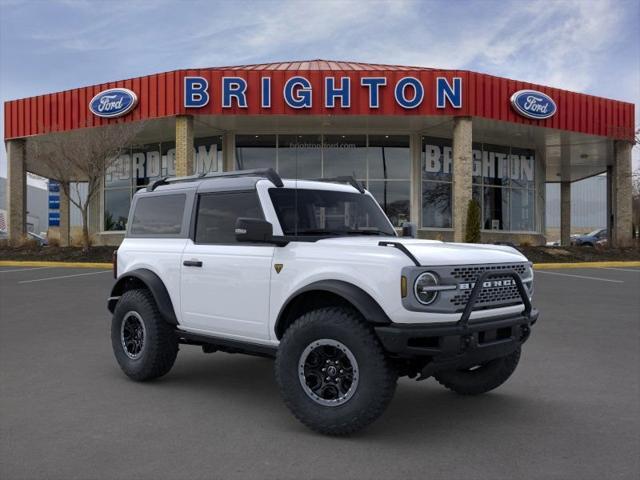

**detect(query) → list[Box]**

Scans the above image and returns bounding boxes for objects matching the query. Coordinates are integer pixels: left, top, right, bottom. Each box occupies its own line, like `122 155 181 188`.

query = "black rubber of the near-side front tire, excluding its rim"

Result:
275 307 398 435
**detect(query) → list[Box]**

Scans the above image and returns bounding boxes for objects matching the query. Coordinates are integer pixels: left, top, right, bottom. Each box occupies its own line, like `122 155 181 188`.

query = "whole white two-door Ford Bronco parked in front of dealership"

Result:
108 169 538 435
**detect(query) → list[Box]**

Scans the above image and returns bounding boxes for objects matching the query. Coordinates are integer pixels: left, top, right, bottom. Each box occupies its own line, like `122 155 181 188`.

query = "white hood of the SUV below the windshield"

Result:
318 236 527 266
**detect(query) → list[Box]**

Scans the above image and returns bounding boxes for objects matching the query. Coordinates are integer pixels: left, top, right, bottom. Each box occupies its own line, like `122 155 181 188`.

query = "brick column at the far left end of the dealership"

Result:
6 140 27 244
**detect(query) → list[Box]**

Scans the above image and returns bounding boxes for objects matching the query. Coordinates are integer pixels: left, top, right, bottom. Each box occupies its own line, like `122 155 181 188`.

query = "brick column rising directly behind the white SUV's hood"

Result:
452 117 473 242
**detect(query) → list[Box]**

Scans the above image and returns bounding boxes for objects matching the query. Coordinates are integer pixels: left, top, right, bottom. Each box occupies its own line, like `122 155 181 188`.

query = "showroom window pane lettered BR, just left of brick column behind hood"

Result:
422 137 453 228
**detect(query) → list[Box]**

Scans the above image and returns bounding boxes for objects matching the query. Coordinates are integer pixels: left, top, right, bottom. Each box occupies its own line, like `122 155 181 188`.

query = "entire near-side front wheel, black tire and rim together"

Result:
275 307 397 435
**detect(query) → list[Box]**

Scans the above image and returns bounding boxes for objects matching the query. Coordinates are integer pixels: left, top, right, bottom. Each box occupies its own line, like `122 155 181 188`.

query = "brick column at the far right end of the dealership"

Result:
610 141 633 247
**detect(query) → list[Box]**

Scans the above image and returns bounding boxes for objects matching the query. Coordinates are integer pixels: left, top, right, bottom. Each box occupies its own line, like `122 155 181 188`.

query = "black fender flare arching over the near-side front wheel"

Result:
274 280 391 338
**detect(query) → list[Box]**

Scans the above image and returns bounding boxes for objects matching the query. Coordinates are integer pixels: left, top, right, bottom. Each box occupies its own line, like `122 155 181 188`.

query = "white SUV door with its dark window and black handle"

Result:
181 190 274 340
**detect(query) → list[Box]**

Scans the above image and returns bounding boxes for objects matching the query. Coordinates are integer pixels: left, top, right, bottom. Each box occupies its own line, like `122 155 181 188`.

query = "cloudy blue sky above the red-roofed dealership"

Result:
0 0 640 180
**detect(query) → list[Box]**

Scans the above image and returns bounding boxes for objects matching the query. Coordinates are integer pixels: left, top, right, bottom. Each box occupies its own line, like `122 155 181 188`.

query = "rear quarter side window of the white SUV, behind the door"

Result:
129 193 187 236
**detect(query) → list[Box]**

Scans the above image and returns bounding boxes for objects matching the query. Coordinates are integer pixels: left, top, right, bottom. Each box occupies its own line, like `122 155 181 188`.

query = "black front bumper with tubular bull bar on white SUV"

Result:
375 271 538 378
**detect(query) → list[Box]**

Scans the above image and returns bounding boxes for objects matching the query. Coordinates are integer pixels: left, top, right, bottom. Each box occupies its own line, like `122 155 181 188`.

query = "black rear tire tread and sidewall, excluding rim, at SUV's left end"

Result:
111 289 178 382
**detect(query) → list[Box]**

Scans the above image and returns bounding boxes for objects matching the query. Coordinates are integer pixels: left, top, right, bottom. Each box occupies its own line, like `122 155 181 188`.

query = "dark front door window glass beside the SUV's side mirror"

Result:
195 191 264 244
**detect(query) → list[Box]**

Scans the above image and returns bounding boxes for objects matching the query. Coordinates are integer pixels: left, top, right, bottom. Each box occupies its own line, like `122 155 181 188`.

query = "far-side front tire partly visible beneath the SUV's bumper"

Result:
434 348 520 395
